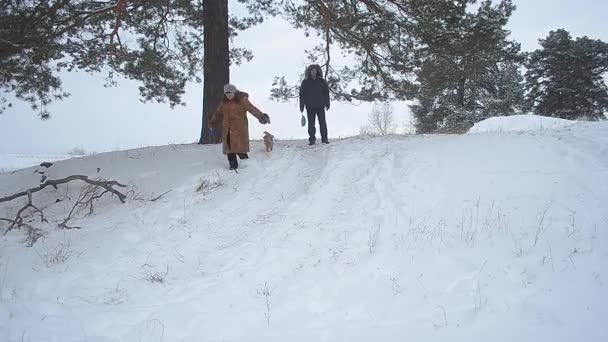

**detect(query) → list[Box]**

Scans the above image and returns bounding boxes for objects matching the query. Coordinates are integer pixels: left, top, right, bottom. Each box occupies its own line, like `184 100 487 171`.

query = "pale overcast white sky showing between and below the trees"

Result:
0 0 608 154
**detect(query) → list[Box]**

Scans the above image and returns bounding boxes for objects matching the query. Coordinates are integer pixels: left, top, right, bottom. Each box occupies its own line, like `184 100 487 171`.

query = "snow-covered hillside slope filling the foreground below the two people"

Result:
0 116 608 342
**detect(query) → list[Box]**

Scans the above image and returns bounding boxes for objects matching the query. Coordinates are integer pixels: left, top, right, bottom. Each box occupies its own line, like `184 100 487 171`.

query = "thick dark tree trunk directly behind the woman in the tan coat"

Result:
199 0 230 144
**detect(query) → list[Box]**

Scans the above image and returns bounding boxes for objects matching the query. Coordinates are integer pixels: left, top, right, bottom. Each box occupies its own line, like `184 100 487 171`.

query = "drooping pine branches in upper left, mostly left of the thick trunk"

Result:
0 0 276 119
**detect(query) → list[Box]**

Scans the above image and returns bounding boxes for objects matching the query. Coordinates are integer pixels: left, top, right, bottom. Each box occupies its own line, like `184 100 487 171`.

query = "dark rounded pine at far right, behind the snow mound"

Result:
526 29 608 120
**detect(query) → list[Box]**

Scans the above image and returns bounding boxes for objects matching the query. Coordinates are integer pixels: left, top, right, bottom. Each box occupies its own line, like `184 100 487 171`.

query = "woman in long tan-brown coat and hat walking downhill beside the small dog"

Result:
209 84 270 170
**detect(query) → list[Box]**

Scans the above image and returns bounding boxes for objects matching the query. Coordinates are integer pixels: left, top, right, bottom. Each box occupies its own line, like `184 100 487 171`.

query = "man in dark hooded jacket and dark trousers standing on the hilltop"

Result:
300 64 329 145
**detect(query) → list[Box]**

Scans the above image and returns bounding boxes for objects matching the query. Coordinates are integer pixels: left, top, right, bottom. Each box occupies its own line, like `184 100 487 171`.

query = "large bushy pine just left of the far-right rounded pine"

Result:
412 1 523 133
